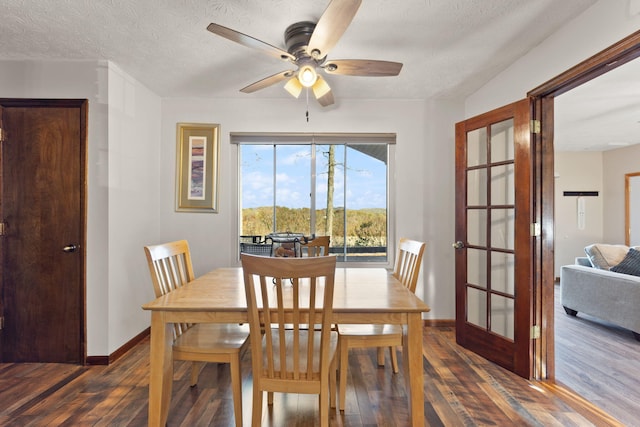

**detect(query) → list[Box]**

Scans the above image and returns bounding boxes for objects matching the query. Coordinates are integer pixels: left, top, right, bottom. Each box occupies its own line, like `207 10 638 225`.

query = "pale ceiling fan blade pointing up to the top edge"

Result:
307 0 362 59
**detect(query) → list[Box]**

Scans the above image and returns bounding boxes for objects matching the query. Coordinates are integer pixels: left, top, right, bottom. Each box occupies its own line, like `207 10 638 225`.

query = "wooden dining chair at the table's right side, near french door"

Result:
338 238 426 411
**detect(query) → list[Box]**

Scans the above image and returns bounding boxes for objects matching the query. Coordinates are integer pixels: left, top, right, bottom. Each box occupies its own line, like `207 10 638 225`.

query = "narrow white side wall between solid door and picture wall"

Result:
106 64 162 354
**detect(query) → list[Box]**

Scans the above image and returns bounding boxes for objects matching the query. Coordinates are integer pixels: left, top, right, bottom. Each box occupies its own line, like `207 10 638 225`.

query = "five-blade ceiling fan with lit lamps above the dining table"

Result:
207 0 402 107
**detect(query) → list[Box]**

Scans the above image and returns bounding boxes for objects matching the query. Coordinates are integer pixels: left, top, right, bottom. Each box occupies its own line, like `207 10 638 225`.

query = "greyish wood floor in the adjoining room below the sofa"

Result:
555 285 640 426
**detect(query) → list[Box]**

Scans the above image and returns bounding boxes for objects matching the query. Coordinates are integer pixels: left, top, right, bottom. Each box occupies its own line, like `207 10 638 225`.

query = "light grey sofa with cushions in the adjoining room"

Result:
560 244 640 341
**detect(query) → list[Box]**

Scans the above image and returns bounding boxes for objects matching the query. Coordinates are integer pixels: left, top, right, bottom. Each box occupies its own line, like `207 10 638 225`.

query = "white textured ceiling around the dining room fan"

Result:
0 0 595 103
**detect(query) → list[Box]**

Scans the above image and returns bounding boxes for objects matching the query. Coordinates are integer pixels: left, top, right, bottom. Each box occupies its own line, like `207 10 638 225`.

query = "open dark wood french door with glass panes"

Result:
455 99 536 378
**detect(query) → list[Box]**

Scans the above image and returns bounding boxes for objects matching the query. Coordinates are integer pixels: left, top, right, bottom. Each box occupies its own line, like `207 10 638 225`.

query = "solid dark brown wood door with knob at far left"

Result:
0 99 87 363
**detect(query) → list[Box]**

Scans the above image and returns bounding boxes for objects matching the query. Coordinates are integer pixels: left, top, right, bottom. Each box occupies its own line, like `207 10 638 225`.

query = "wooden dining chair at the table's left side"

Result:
144 240 249 427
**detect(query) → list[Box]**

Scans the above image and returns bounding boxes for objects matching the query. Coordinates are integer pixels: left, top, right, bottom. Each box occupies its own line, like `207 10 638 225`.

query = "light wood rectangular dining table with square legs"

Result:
142 268 430 427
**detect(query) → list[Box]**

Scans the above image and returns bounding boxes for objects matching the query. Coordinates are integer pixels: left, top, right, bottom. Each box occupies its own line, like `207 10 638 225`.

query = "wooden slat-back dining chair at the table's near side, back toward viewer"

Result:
241 254 338 427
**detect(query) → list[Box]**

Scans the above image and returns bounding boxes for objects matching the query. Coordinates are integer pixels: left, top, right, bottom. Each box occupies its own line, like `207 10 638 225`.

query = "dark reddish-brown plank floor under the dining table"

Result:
0 327 616 427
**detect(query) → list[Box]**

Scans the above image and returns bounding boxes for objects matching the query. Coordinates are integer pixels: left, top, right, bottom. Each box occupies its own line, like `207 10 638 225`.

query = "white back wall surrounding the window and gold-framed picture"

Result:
161 97 462 319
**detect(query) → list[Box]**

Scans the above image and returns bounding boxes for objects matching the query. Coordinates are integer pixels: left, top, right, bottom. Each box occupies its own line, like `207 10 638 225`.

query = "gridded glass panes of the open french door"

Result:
466 119 515 340
